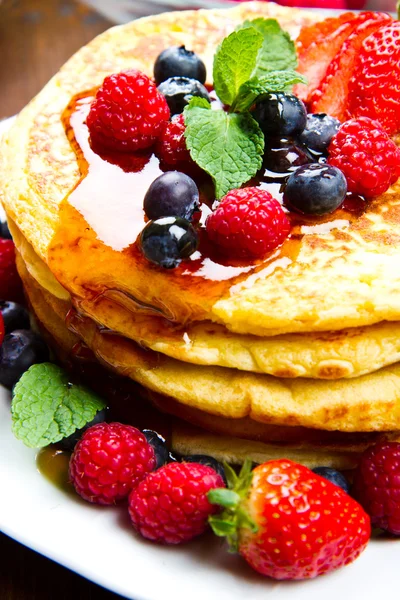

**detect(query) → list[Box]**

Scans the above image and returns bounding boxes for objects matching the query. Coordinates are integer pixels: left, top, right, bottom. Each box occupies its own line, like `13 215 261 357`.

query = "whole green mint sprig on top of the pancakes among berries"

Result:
184 18 306 199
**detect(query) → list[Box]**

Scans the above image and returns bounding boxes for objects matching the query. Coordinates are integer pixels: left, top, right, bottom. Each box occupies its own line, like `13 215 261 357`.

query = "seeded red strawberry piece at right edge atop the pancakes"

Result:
349 21 400 134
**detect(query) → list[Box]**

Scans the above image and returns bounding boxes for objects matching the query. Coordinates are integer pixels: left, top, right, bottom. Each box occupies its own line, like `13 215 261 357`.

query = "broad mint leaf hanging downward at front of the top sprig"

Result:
185 106 264 198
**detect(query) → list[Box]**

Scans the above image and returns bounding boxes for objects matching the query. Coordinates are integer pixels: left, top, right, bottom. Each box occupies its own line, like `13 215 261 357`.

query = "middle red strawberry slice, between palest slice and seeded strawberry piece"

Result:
308 13 393 121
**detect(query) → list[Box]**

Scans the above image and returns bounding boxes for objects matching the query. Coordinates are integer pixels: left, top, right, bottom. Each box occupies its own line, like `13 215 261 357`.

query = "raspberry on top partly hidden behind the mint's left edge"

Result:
155 113 192 165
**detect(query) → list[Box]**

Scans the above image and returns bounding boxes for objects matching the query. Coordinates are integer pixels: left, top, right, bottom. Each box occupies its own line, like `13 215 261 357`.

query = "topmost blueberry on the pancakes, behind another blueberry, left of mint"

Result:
154 46 206 85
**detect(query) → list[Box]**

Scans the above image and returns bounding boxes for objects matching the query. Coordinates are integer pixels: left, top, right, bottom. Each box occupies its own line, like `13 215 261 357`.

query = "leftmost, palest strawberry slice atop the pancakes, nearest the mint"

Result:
294 12 391 104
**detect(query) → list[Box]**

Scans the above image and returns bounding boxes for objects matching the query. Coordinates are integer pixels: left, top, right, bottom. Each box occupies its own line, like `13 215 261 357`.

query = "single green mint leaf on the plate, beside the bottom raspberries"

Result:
11 363 106 448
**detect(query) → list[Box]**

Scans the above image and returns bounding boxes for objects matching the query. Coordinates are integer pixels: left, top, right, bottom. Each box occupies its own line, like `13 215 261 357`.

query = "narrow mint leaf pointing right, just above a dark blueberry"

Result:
232 71 307 112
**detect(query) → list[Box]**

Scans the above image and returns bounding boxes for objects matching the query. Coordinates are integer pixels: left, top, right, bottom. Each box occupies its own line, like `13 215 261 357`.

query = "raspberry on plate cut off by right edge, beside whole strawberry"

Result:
352 442 400 535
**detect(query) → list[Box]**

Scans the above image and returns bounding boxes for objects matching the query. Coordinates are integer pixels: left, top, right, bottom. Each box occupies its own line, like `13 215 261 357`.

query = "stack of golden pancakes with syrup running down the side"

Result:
0 2 400 468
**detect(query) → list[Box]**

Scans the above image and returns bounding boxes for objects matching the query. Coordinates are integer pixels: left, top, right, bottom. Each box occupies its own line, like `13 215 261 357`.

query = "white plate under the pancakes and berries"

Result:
0 116 400 600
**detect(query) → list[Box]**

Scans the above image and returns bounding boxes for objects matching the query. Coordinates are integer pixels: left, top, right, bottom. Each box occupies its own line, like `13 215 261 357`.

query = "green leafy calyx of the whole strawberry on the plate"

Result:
207 459 258 552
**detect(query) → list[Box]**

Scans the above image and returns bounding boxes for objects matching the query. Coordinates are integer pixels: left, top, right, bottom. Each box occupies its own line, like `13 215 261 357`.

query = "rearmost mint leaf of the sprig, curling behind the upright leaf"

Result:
237 17 297 79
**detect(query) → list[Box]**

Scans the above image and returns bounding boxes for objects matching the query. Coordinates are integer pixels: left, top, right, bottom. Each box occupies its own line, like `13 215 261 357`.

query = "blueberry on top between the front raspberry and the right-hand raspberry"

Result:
283 163 347 215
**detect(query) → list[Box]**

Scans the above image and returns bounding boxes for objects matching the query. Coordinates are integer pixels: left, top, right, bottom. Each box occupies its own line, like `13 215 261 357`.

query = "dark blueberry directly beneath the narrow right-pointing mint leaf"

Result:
253 92 307 138
